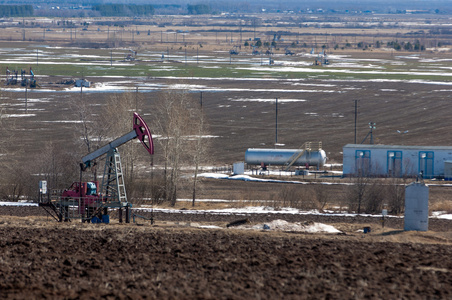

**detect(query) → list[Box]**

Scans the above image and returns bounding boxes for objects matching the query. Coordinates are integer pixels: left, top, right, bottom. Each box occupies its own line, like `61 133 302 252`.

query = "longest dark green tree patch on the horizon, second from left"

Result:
92 4 154 17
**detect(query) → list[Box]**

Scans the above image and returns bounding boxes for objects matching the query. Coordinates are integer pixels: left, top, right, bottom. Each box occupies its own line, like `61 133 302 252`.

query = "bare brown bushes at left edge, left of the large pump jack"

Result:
0 91 77 201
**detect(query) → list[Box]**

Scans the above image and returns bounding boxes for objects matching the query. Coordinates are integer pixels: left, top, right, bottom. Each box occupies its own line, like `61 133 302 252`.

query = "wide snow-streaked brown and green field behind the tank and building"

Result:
3 50 452 164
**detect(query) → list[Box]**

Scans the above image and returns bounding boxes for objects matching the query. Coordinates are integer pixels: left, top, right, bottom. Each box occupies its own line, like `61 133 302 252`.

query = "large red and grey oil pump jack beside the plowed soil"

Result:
39 113 154 223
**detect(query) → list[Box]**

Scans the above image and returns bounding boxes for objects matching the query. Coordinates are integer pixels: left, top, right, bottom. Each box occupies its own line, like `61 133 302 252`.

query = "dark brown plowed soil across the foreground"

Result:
0 215 452 299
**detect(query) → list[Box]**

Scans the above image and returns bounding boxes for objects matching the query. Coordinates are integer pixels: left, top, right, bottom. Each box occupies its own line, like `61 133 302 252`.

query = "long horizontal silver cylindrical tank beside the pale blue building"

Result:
245 148 326 167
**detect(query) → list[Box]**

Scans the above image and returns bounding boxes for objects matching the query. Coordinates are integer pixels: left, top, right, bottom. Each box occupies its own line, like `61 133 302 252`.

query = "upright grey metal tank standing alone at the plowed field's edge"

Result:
404 182 428 231
